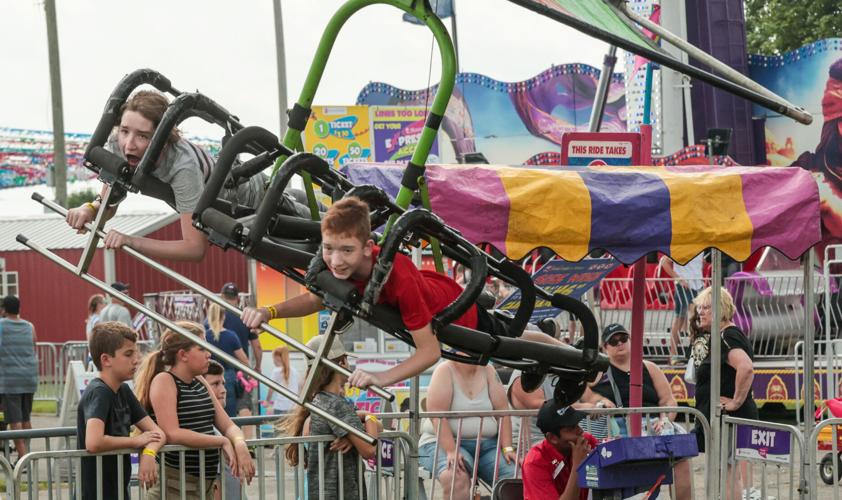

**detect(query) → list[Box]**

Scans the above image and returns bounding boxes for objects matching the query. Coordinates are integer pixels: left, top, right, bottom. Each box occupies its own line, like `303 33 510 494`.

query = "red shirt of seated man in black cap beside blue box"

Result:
523 432 597 500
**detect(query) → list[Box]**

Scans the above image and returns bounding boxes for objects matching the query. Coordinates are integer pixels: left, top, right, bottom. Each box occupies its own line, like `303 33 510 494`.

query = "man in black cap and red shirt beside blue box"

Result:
523 399 597 500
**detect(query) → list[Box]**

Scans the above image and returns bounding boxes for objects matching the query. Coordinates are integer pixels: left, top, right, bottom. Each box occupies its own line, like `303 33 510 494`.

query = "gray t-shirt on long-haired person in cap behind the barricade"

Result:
307 392 365 500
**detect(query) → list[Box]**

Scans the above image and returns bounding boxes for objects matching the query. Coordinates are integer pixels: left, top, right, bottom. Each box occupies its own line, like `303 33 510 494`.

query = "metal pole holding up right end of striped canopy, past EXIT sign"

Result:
800 248 812 498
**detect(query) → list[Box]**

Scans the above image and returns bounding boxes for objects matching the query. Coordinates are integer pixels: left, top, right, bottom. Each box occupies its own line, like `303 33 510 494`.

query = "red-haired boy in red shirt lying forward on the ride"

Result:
242 197 561 388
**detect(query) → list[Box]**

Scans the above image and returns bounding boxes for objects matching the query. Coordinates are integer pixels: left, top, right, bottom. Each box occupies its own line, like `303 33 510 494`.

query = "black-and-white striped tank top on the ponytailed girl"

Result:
149 372 219 479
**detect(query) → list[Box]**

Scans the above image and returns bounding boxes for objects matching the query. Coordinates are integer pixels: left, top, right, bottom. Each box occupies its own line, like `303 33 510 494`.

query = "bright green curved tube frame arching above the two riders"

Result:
272 0 456 223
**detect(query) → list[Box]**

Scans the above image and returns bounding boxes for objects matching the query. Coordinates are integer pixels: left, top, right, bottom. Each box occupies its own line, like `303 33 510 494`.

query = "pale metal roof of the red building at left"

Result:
0 212 178 252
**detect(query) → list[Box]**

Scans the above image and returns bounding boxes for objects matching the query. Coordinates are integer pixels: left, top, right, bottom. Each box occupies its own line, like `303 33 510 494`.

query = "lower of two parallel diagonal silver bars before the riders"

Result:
16 234 377 444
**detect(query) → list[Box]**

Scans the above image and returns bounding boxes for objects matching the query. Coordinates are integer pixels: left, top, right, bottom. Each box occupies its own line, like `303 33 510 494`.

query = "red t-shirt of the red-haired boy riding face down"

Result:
352 245 477 330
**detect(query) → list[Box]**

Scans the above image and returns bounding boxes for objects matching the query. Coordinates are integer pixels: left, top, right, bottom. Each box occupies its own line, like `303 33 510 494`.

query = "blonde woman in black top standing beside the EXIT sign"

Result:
688 287 759 498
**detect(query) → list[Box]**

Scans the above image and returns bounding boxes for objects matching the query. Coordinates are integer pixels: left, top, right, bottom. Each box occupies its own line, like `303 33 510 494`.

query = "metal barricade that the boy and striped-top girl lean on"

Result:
9 432 417 500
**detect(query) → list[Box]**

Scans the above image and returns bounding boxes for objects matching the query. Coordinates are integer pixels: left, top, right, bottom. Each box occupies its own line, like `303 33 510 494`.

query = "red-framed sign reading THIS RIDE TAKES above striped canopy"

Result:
561 132 641 167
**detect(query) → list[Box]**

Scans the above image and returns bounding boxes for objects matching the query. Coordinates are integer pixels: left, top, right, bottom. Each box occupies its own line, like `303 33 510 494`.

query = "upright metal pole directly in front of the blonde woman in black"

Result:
705 248 722 498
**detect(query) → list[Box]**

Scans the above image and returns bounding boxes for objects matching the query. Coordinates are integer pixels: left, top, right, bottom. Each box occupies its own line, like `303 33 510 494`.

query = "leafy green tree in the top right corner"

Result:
745 0 842 55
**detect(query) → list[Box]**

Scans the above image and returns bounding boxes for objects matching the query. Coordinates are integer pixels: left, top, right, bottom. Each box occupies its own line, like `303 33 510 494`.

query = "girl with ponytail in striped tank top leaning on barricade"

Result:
135 321 254 499
